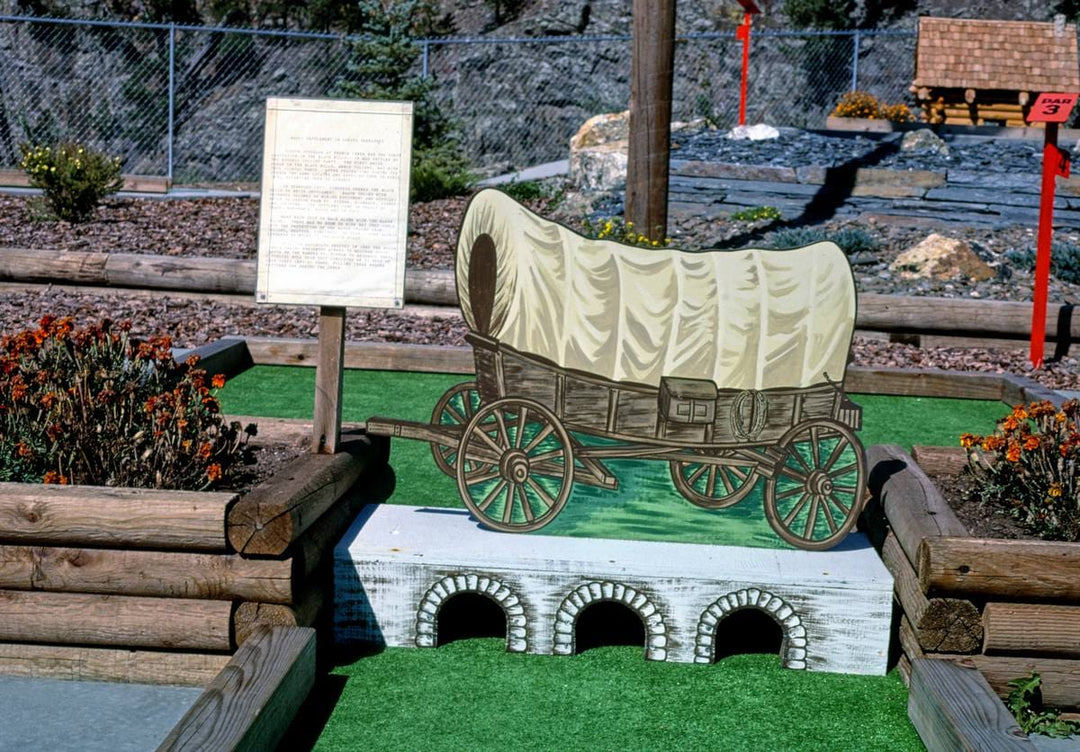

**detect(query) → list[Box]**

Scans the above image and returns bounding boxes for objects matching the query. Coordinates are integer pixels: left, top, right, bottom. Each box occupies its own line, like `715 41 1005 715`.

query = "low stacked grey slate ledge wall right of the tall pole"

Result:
670 161 1080 228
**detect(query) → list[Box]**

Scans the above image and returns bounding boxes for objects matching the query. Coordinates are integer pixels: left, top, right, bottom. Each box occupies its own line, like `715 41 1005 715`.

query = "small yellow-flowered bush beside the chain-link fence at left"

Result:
18 143 123 223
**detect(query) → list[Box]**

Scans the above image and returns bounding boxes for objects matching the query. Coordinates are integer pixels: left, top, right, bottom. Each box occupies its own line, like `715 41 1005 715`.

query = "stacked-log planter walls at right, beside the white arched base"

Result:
866 446 1080 747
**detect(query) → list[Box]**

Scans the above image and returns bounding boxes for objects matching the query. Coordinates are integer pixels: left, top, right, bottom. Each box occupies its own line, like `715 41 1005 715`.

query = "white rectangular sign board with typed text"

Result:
255 98 413 308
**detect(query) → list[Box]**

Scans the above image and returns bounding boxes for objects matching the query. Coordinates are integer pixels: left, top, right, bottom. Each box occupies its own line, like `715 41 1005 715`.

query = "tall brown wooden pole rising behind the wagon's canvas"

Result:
626 0 675 240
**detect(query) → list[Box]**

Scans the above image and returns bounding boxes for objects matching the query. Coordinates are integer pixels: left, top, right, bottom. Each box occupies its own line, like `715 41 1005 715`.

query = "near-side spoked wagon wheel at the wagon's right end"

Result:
765 418 866 551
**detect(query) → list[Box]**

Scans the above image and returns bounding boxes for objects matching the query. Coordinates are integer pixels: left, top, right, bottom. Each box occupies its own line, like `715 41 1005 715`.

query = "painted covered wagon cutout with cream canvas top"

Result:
367 190 866 549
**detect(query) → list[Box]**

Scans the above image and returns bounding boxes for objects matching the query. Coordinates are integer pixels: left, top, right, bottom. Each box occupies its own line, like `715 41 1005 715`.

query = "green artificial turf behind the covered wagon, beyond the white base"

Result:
214 366 1007 548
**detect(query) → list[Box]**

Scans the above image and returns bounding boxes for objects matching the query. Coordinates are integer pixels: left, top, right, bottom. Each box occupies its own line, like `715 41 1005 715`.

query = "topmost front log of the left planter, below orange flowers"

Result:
0 483 237 553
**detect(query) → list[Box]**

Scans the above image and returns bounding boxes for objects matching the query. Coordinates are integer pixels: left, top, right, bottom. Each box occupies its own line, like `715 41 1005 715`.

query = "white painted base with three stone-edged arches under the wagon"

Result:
334 505 892 674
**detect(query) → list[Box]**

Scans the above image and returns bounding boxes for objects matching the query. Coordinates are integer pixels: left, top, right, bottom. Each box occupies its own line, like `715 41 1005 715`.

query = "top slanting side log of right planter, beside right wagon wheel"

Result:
866 444 968 566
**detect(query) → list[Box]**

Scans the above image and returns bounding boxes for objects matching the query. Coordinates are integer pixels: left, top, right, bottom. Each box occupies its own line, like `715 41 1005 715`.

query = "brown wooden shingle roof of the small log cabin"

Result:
915 16 1080 92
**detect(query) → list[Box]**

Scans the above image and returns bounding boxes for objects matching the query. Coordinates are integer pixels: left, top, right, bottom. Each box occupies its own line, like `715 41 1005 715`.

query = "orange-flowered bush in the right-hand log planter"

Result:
960 400 1080 540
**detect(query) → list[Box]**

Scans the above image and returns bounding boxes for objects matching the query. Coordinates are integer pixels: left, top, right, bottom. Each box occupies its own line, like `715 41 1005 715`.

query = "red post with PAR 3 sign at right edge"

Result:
1028 94 1077 368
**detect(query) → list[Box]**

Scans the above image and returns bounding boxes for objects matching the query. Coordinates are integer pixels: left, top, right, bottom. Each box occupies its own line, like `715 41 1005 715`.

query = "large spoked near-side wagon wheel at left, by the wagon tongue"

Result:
457 398 573 533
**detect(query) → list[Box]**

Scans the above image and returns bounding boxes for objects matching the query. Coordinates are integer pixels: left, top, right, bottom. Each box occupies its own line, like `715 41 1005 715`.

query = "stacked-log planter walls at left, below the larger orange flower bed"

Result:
0 435 388 685
